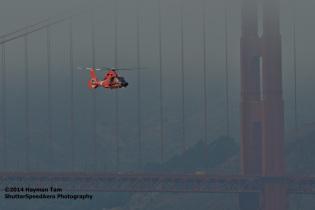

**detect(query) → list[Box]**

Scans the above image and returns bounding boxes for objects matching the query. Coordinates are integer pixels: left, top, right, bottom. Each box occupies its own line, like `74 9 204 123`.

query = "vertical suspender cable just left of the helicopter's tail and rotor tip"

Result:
69 19 75 171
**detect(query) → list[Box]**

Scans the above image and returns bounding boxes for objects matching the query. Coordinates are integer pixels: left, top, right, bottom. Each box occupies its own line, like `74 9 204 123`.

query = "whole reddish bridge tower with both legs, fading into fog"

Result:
239 0 287 210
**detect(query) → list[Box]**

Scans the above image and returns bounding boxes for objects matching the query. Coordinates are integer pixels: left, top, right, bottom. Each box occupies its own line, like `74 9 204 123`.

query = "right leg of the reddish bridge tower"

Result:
261 0 287 210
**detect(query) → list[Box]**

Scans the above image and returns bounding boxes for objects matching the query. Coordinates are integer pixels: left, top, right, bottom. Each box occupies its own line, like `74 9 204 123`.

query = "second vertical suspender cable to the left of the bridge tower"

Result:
202 0 209 168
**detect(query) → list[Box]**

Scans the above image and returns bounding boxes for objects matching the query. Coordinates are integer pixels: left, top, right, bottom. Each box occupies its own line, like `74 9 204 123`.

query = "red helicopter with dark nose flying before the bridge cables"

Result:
78 67 133 89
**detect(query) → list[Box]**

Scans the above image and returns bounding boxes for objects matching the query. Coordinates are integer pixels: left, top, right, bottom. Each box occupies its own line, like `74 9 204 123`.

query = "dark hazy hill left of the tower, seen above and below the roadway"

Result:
122 137 239 210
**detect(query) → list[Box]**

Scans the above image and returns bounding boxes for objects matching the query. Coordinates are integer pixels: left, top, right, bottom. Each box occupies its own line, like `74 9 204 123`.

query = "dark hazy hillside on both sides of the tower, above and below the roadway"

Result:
121 126 315 210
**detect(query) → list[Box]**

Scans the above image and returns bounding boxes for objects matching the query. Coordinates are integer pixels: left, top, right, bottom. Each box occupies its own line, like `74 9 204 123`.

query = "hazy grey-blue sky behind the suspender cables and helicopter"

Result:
0 0 315 171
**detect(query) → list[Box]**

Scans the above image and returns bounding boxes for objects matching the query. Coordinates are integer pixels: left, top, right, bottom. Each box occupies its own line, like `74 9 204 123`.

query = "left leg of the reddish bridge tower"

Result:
239 0 263 210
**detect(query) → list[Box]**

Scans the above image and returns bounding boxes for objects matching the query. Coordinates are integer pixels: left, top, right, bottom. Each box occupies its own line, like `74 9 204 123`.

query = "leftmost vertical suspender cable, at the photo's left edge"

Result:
1 44 8 171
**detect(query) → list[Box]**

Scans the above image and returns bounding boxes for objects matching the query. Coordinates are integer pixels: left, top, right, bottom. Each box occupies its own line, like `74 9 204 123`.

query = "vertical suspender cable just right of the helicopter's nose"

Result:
137 0 143 170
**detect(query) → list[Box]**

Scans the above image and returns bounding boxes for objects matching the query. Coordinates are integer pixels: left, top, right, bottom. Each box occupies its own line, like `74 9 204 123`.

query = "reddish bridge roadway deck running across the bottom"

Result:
0 173 315 194
